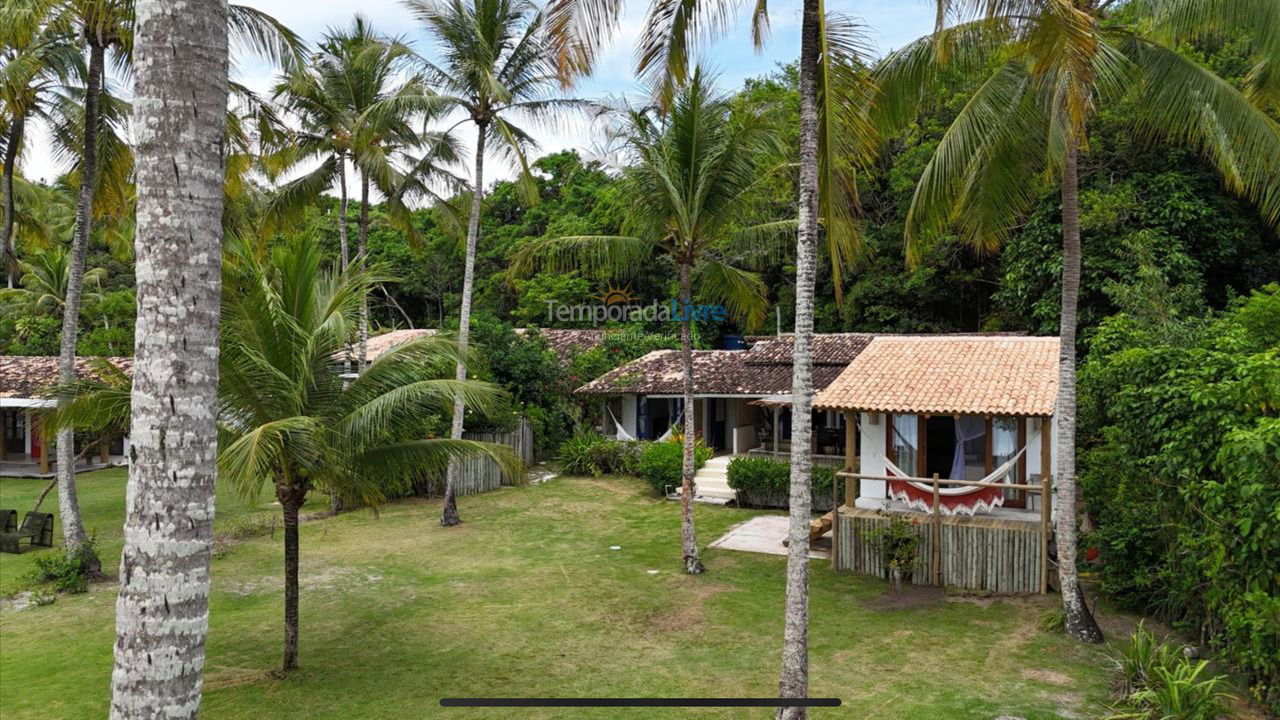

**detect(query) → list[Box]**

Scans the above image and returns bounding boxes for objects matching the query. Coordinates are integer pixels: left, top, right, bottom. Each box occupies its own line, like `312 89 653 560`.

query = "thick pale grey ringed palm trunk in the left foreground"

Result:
111 0 228 719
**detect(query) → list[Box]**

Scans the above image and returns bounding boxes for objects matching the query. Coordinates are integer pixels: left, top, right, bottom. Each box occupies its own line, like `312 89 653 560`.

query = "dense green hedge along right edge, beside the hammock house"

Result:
1080 286 1280 710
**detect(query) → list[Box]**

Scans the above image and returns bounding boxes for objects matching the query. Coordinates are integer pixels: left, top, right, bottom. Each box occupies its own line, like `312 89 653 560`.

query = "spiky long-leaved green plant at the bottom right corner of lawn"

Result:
1111 624 1233 720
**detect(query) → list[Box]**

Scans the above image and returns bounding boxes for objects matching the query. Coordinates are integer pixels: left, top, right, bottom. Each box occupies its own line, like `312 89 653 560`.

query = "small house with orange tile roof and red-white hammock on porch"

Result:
814 336 1059 593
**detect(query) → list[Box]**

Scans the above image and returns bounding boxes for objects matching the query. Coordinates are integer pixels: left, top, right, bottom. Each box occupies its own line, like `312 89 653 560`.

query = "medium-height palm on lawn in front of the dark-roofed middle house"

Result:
512 68 773 574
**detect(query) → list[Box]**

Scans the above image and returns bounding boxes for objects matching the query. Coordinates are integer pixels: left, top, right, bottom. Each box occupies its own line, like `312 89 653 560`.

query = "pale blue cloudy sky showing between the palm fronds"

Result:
22 0 934 193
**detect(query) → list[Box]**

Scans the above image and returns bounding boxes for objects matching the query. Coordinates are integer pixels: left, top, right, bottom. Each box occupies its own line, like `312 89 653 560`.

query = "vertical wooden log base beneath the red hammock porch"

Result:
832 505 1044 594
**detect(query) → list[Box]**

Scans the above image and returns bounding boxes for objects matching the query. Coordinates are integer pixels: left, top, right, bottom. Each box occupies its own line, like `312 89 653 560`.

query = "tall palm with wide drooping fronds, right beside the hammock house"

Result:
877 0 1280 642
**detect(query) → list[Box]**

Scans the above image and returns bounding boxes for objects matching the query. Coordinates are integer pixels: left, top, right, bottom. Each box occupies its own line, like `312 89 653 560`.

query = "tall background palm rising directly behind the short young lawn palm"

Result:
271 15 456 369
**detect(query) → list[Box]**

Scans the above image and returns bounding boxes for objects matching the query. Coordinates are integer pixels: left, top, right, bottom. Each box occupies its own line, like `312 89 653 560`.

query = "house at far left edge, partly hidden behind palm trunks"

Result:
0 355 133 477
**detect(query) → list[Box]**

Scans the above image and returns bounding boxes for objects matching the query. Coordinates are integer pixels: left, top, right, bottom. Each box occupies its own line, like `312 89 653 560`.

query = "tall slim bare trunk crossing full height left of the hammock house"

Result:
776 0 838 707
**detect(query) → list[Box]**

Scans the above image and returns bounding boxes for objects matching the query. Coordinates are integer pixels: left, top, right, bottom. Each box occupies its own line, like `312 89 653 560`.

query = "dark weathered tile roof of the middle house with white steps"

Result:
576 334 872 396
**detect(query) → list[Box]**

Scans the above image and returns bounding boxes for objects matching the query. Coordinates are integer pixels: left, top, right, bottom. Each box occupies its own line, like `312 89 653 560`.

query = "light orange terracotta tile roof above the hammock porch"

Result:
814 336 1059 416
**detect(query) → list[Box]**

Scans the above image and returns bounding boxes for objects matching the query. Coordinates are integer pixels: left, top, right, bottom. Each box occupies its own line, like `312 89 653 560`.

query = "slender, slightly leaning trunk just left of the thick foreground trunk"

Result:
58 41 106 574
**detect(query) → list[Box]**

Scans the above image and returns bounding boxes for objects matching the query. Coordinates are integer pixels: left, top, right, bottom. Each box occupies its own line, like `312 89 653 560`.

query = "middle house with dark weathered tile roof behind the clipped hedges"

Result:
576 333 873 465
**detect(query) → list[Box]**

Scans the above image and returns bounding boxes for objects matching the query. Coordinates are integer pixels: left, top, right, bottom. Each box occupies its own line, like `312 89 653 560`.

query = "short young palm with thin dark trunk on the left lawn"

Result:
58 238 522 670
